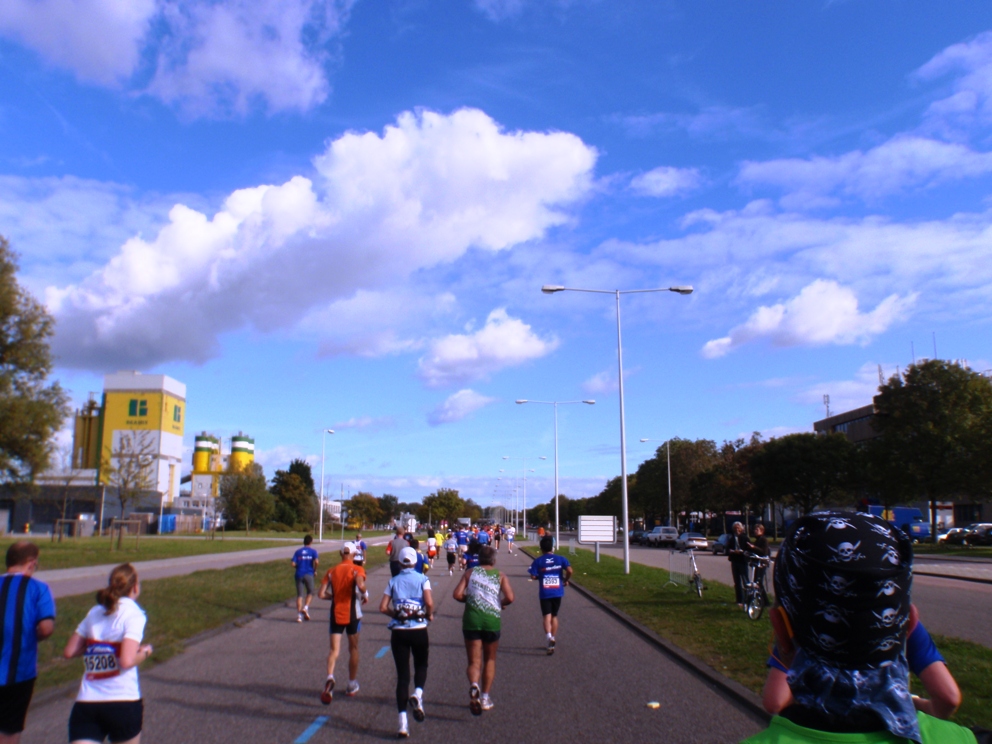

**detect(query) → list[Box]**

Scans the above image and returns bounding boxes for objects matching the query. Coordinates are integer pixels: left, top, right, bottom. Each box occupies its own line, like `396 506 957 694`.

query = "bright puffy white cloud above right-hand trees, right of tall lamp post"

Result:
702 279 916 359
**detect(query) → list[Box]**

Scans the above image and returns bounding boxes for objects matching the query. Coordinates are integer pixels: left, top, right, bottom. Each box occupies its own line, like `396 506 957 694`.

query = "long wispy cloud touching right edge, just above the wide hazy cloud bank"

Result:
737 135 992 207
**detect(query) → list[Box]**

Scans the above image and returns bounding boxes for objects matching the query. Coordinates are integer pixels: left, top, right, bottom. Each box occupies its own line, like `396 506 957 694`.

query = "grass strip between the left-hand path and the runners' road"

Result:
37 547 386 689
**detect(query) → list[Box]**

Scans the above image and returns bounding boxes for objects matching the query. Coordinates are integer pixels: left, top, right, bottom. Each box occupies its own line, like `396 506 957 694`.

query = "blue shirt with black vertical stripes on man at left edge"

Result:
0 574 55 685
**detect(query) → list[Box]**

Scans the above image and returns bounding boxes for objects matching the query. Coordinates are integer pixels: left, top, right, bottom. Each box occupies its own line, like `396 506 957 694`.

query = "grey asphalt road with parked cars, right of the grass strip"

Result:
596 545 992 648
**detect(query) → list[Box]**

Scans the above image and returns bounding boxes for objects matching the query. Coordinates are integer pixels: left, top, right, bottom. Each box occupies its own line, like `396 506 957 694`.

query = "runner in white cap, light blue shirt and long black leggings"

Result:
379 547 434 738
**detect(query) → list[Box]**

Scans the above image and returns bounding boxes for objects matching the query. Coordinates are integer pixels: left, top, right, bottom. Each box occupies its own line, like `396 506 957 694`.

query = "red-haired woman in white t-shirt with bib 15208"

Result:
64 563 152 744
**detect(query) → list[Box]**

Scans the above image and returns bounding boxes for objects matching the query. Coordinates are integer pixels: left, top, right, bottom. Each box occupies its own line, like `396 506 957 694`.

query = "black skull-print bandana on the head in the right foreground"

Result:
774 511 920 741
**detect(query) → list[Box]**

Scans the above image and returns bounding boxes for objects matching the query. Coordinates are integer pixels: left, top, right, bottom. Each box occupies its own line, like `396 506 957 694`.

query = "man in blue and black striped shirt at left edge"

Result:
0 542 55 744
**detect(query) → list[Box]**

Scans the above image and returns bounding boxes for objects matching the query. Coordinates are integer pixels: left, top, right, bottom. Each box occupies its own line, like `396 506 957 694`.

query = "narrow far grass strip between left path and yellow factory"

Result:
0 535 294 571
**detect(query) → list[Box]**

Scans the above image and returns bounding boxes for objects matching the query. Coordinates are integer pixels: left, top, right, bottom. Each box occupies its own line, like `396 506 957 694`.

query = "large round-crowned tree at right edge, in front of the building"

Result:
873 360 992 541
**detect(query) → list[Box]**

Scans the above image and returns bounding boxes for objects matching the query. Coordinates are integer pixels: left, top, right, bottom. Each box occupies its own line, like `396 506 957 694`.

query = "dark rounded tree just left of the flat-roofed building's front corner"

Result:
751 434 855 514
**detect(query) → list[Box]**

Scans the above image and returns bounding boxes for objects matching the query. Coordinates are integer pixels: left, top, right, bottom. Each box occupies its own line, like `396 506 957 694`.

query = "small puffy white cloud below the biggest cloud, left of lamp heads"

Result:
420 308 558 387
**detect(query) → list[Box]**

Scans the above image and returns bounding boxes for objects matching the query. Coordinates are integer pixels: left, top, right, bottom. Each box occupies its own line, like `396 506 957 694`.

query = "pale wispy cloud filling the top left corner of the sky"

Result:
0 0 354 116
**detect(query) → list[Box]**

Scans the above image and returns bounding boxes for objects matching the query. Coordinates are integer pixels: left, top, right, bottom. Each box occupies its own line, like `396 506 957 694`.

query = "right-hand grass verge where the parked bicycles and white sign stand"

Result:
552 549 992 728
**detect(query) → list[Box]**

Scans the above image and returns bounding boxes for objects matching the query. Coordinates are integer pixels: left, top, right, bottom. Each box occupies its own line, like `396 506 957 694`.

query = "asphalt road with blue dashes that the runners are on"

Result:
22 553 762 744
